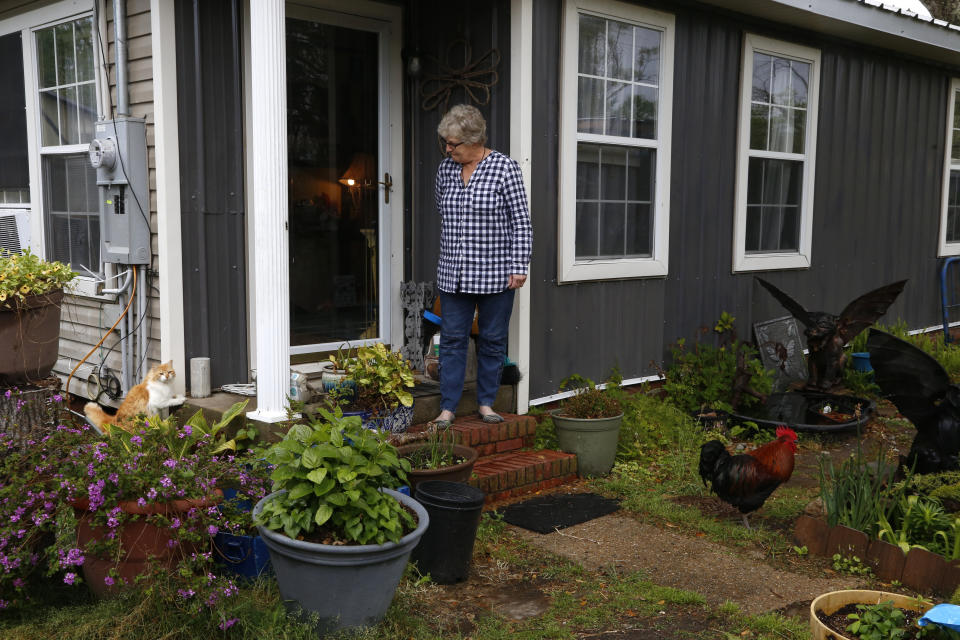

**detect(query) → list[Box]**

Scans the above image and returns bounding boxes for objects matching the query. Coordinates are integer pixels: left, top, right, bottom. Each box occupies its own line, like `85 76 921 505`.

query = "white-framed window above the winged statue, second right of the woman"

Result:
733 34 820 271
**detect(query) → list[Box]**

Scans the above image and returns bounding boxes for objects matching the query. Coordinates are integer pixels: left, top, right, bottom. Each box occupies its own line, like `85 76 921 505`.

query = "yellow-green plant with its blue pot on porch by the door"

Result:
330 342 414 433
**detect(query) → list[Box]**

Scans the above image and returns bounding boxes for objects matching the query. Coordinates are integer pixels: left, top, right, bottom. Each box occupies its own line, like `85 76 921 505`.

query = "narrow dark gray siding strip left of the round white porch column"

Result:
174 0 248 387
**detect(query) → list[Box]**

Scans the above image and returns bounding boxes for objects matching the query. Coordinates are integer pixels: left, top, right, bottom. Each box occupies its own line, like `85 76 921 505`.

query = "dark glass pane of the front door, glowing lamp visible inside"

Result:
286 5 390 354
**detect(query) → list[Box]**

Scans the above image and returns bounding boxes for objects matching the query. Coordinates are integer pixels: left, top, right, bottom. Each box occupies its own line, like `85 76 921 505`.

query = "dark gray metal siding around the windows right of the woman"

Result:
530 0 956 398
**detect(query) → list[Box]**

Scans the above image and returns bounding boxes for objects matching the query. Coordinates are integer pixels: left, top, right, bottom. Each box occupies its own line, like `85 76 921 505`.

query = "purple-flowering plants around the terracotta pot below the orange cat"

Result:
0 403 265 624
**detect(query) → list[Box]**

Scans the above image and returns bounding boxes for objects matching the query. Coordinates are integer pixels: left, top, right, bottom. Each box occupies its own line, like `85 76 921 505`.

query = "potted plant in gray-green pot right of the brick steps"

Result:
550 374 623 477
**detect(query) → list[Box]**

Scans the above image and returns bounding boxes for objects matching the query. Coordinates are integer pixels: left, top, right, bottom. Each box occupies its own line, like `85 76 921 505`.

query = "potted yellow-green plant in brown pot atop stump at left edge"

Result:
0 249 77 385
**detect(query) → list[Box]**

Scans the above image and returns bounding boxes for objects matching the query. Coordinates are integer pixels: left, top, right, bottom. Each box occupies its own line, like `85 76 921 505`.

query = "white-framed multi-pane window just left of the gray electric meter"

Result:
33 16 100 273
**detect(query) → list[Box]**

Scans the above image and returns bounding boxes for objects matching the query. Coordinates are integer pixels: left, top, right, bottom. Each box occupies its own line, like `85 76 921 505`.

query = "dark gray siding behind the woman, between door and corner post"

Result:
404 0 510 282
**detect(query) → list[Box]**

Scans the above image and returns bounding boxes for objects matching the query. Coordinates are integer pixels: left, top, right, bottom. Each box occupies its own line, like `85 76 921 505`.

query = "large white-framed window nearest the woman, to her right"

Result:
559 0 674 282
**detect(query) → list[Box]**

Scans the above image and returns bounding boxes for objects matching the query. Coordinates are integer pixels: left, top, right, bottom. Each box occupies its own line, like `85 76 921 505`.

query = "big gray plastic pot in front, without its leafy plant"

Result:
253 489 430 633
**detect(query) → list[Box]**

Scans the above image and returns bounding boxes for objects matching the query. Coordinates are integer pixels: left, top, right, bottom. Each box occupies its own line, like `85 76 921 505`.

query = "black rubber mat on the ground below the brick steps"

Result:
499 493 620 533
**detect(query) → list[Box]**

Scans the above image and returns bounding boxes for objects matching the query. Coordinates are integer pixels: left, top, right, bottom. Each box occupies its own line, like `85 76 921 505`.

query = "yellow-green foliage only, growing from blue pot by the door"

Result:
330 342 414 416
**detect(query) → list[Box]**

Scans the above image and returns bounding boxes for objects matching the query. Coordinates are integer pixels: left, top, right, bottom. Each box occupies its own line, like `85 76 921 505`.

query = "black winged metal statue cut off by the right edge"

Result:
867 329 960 473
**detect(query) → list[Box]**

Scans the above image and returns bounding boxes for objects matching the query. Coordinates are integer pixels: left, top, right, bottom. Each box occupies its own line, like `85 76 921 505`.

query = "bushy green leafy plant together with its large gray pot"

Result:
253 407 429 632
